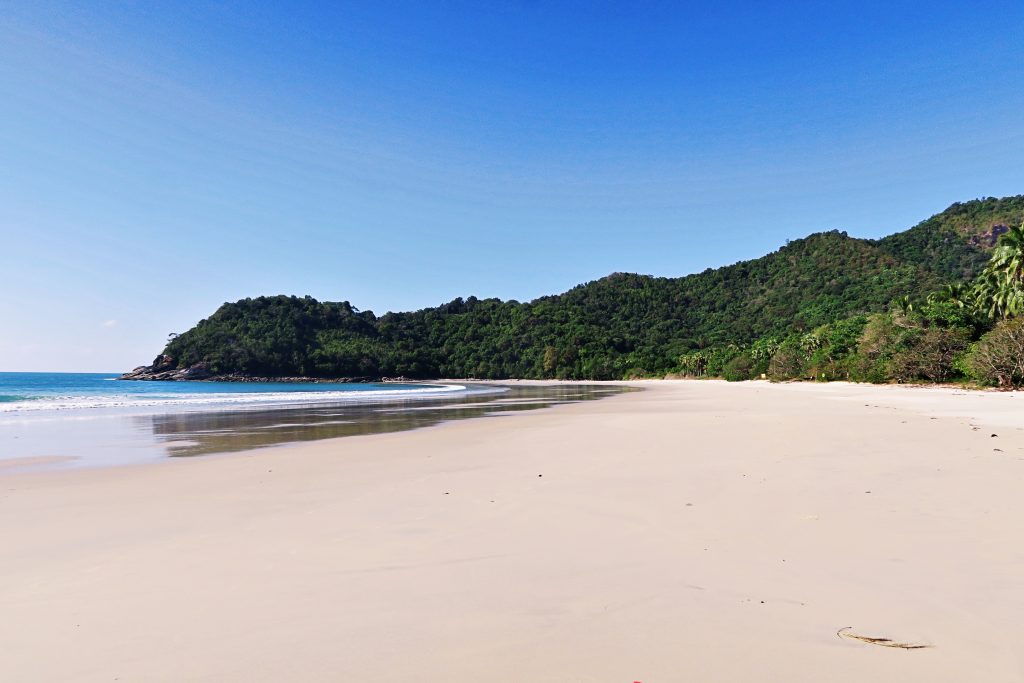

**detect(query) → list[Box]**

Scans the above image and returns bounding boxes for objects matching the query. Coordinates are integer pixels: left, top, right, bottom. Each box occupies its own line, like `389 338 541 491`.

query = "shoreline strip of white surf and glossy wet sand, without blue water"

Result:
0 383 626 474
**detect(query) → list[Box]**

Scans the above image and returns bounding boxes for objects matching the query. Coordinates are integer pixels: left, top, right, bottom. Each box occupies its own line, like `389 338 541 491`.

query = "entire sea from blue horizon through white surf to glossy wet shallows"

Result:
0 373 628 476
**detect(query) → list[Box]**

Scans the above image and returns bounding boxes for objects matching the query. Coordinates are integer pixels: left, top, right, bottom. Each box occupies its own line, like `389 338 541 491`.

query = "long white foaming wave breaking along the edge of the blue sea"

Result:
0 384 467 414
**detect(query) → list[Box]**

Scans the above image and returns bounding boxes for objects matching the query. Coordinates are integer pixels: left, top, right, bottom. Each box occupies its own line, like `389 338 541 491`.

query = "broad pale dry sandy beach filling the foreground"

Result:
0 381 1024 683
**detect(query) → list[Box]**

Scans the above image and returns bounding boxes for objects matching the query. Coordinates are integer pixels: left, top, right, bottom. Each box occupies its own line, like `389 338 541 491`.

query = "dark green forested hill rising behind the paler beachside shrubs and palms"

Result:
136 196 1024 379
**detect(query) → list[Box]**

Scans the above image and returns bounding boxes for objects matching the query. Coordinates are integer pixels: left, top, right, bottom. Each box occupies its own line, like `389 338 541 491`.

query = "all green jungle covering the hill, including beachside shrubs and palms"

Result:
153 196 1024 385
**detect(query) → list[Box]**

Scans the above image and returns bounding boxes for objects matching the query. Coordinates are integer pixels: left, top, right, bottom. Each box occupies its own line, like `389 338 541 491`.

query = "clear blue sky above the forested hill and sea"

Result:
0 0 1024 372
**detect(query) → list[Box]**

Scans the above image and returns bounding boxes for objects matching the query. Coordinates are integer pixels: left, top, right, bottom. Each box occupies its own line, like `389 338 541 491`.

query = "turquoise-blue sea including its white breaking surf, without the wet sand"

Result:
0 373 466 415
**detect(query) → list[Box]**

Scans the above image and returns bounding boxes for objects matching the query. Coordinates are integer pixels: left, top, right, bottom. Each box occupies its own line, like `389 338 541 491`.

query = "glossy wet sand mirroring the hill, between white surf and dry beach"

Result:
0 384 633 475
